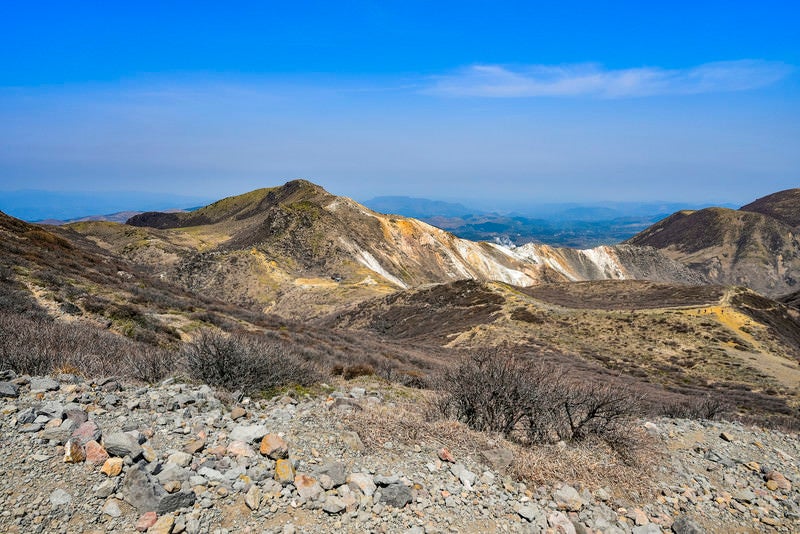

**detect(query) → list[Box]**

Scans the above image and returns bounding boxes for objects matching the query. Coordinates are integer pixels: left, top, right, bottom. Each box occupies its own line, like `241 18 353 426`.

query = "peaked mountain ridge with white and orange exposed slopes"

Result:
70 180 705 317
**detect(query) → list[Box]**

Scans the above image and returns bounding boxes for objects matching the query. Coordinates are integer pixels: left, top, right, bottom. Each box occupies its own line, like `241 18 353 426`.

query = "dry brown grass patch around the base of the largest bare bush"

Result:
344 391 663 497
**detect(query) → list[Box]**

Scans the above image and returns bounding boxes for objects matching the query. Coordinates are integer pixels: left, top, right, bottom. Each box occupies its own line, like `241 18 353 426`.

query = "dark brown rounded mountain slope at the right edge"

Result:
627 189 800 297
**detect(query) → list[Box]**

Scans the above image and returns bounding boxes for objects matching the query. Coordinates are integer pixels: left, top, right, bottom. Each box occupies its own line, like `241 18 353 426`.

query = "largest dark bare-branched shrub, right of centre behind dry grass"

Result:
438 350 641 452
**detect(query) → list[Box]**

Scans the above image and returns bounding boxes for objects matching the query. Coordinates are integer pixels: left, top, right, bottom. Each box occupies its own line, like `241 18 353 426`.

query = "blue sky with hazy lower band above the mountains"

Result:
0 0 800 216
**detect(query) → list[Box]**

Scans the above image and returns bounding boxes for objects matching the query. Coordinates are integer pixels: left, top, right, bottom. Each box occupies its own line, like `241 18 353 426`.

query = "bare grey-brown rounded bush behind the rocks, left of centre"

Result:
183 330 321 393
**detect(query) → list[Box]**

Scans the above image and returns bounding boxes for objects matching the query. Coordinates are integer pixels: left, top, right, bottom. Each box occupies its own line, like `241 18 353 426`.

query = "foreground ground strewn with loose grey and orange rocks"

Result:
0 373 800 534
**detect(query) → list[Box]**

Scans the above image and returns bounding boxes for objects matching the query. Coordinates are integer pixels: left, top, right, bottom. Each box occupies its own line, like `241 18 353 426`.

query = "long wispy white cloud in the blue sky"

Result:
425 60 792 98
